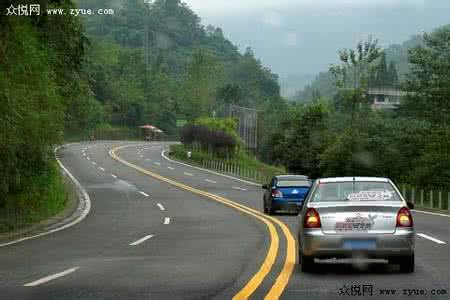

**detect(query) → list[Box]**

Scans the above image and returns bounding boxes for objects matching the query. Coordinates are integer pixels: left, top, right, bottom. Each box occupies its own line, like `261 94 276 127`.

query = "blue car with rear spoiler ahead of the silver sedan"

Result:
262 175 312 215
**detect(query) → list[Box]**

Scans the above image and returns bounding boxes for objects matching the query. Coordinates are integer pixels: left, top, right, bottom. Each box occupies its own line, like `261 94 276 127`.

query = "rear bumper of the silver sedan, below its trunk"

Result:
298 228 414 258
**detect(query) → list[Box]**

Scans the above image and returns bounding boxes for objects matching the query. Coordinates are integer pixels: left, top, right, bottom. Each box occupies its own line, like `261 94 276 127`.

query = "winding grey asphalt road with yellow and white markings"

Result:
0 142 450 299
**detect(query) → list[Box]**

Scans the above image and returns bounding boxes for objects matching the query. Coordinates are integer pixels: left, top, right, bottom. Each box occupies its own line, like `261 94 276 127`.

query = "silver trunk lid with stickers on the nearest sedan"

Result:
310 201 402 235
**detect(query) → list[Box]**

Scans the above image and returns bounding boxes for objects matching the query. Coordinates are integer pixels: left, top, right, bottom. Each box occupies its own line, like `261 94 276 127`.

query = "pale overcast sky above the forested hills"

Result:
184 0 450 94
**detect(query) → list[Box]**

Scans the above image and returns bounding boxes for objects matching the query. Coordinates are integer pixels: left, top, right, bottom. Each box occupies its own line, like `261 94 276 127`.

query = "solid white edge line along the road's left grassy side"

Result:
0 143 91 247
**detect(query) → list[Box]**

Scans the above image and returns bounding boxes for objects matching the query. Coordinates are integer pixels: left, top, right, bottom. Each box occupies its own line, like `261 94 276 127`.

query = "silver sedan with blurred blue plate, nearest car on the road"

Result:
298 177 414 272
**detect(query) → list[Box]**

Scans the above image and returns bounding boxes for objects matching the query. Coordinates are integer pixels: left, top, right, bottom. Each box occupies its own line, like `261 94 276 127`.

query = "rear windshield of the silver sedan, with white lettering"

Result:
311 181 401 202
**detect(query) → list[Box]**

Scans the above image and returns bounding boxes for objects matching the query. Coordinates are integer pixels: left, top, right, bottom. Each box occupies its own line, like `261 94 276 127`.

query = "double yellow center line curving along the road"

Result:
109 145 295 299
